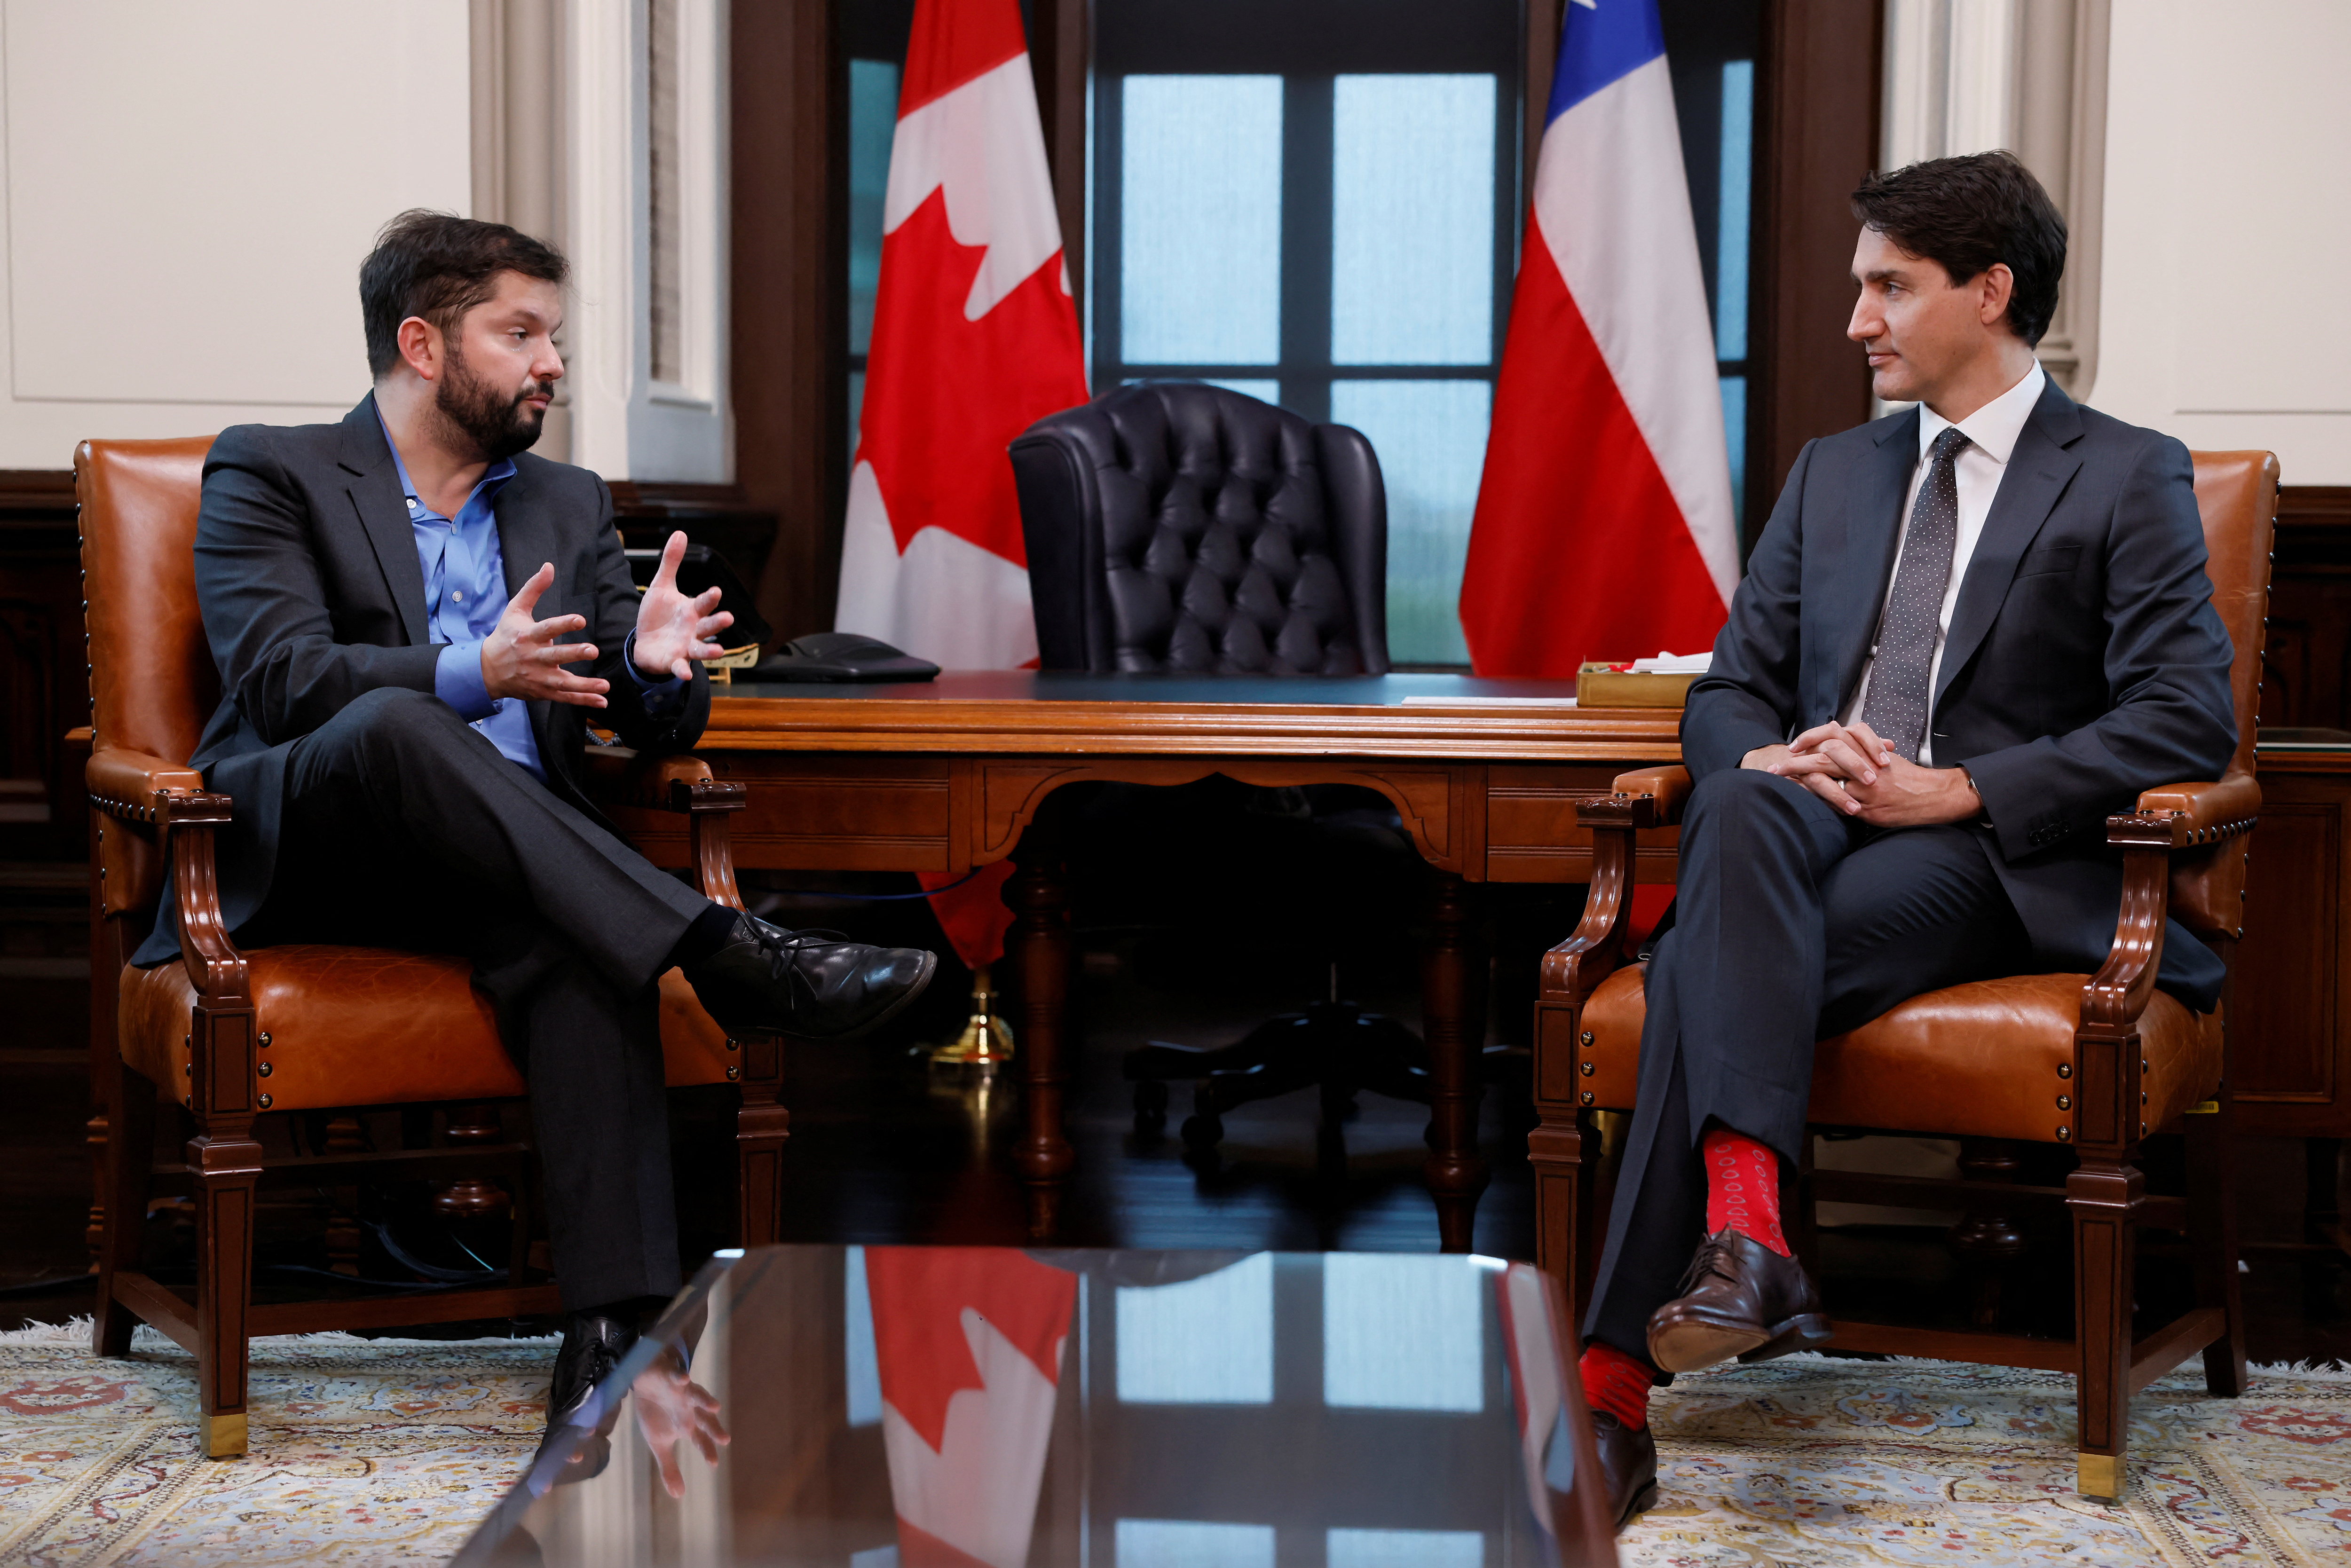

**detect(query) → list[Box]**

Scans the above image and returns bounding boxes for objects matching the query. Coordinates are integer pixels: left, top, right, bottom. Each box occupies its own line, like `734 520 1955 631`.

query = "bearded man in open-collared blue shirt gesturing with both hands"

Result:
139 212 936 1429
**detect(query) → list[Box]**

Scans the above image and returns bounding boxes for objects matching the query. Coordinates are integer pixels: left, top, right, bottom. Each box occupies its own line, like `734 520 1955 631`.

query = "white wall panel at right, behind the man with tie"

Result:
2090 0 2351 484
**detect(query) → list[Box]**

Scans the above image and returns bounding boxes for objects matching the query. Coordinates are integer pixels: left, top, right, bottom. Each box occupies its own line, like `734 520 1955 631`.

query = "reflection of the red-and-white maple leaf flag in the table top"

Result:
865 1246 1077 1568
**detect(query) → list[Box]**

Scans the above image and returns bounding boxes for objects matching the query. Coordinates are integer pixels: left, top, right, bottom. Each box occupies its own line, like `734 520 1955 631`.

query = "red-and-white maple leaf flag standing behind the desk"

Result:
835 0 1086 966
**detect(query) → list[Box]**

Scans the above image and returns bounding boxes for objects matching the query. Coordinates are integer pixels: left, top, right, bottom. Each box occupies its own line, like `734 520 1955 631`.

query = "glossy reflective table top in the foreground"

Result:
456 1246 1615 1568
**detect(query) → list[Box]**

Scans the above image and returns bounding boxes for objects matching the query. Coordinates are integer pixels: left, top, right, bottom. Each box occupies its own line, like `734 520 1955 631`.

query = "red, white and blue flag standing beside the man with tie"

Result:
1460 0 1737 677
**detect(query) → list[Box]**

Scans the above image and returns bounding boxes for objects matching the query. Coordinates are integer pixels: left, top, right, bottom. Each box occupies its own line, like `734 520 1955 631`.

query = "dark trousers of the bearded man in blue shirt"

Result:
240 691 710 1309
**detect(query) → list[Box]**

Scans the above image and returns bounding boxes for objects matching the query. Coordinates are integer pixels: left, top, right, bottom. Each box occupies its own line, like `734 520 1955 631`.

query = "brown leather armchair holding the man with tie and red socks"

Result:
1528 451 2278 1497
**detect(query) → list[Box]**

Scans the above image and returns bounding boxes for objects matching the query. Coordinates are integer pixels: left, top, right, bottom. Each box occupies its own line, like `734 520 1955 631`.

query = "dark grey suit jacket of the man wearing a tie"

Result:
1681 381 2236 1009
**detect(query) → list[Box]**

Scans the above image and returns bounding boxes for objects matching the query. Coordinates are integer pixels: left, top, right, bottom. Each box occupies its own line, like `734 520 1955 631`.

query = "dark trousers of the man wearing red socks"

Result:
1585 771 2031 1356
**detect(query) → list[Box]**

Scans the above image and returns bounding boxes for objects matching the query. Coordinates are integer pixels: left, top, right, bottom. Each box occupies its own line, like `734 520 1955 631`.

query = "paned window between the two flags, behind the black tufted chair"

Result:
1086 0 1521 663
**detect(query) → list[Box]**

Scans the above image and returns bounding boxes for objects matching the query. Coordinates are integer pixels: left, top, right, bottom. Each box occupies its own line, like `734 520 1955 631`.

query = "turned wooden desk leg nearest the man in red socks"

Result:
1420 872 1486 1253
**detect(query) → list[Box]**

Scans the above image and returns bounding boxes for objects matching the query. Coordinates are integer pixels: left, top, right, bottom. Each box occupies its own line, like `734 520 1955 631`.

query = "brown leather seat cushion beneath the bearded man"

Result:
120 943 741 1110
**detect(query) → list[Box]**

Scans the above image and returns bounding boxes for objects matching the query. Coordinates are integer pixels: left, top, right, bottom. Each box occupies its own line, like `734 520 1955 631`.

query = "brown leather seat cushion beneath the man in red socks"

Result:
1556 964 2219 1143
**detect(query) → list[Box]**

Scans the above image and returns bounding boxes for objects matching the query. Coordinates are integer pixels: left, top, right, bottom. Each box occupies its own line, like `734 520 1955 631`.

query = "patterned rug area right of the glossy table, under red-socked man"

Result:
1620 1356 2351 1568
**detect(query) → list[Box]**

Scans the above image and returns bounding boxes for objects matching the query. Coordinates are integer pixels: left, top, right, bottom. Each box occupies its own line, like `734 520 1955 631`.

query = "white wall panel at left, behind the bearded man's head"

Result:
0 0 470 468
